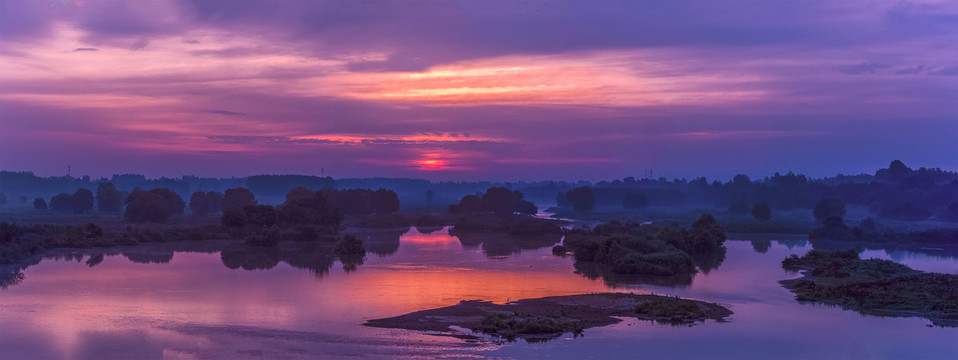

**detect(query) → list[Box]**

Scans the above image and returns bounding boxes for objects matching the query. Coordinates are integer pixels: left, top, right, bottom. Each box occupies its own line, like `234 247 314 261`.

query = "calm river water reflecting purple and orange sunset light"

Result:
0 229 958 359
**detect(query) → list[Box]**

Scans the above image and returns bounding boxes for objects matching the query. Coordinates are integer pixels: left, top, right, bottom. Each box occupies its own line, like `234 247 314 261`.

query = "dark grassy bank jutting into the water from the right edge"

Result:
781 250 958 327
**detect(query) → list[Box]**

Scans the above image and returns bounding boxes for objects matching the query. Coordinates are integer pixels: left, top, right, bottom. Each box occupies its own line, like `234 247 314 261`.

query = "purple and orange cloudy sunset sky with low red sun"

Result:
0 0 958 181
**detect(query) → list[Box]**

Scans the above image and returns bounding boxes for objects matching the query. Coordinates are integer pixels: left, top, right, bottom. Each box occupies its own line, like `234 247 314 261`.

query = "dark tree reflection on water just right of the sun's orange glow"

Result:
451 231 562 258
